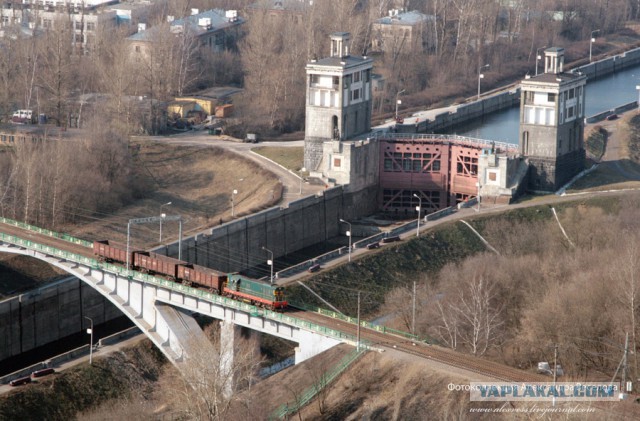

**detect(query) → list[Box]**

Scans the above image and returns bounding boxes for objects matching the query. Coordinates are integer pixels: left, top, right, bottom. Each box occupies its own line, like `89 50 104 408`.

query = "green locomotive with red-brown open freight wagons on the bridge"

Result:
93 240 287 310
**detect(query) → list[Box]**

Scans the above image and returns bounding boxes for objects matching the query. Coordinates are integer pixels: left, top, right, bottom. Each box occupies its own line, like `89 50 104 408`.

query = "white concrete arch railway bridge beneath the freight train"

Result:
0 218 356 372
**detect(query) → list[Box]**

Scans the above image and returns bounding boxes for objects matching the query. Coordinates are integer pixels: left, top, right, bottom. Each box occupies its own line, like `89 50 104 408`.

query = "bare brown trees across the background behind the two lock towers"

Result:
0 0 640 133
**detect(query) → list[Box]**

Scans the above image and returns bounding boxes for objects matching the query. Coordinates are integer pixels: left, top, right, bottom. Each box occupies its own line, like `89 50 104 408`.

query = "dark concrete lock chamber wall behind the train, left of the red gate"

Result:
161 186 377 272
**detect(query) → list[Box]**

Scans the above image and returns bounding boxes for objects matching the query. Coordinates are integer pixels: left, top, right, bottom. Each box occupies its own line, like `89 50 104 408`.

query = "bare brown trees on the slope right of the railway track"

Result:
386 195 640 379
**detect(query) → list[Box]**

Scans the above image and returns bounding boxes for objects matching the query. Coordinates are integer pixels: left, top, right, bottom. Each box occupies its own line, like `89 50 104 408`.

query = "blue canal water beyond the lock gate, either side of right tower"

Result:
448 66 640 144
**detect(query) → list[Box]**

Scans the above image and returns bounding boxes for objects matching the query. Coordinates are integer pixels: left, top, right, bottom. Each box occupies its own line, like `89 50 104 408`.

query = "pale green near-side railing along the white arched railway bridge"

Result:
0 233 370 348
